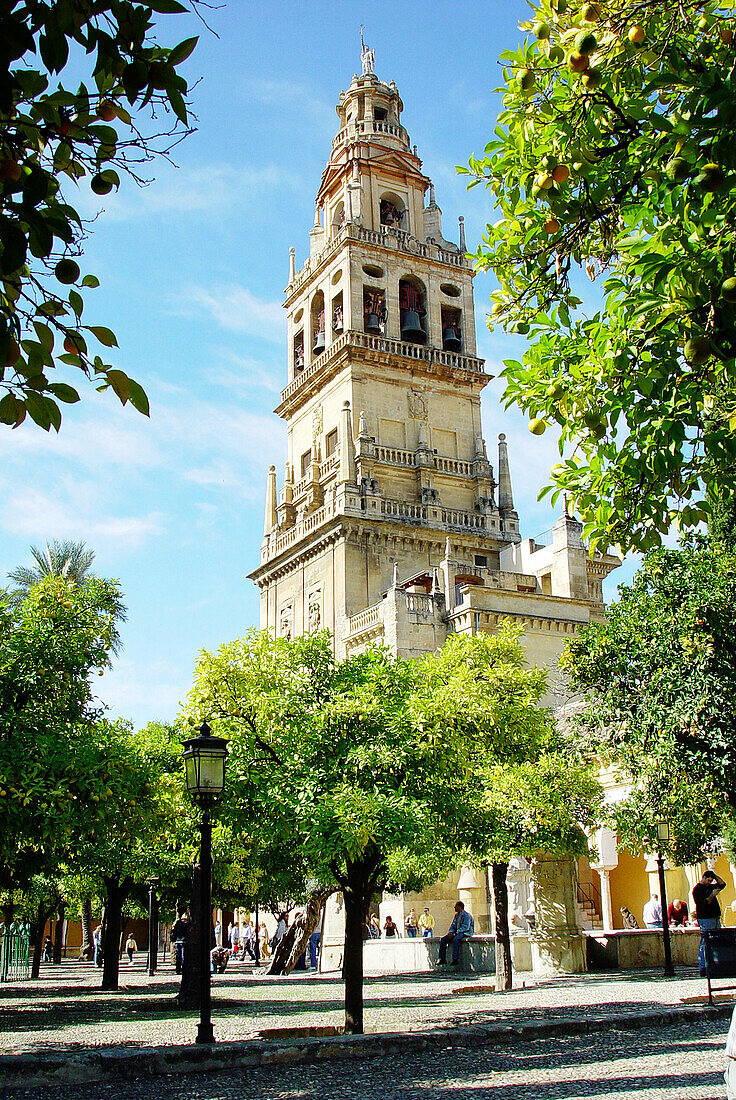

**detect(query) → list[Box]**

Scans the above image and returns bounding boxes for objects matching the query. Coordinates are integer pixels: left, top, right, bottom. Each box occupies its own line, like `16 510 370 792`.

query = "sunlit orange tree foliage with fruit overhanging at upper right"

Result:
468 0 736 550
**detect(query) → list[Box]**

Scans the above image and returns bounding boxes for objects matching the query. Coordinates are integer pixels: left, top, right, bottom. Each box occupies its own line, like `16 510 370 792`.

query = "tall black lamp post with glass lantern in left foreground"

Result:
184 722 228 1043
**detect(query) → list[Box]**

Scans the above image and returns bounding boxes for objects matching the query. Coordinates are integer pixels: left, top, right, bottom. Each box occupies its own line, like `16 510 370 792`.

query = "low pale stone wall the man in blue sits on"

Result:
319 936 496 975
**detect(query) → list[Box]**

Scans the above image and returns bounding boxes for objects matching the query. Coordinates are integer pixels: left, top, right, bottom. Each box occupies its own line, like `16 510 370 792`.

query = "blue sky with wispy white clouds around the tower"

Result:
0 0 630 724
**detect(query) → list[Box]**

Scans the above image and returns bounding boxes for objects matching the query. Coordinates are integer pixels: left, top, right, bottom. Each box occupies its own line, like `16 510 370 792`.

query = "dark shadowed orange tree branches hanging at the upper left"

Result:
0 0 198 431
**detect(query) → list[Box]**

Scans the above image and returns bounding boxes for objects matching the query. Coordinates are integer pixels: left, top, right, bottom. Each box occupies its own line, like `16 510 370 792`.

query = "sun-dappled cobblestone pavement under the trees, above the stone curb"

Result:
0 960 721 1054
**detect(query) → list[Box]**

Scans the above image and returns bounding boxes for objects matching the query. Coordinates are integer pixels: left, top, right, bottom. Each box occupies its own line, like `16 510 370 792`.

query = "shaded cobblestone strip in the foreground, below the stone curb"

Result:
0 1020 727 1100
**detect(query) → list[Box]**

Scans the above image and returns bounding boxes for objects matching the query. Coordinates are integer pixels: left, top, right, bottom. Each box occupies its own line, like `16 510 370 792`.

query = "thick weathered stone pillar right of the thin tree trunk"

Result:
530 853 586 977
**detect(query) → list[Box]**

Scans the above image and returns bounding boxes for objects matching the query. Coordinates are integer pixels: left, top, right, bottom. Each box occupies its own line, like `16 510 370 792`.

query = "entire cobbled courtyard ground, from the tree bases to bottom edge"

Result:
0 958 732 1100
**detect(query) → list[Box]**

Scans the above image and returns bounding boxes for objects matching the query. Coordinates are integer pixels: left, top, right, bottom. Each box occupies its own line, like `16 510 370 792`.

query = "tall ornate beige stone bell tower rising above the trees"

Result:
250 53 616 657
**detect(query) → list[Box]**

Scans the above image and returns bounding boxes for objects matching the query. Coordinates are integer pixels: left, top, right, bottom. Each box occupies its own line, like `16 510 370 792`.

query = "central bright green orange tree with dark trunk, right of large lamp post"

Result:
187 627 556 1032
